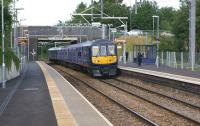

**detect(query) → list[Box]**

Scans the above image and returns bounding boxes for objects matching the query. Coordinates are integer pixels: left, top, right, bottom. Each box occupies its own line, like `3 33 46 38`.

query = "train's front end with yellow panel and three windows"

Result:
91 42 118 77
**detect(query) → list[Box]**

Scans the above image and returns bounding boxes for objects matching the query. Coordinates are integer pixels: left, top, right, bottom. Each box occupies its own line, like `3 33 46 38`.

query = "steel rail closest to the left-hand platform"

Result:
56 67 159 126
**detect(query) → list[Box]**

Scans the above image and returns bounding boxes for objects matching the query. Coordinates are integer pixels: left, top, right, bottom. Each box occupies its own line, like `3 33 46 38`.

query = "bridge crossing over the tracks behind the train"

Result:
17 25 102 60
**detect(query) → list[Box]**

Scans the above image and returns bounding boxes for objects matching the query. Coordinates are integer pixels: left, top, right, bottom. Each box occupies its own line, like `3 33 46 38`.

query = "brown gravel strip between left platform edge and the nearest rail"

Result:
56 66 147 126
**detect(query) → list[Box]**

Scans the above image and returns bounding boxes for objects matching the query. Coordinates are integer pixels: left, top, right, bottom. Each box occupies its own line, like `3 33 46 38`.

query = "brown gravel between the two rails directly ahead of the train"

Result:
106 79 200 122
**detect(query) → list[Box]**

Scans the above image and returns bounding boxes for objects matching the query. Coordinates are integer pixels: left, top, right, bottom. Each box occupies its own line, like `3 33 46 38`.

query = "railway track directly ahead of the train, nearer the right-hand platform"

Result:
101 79 200 124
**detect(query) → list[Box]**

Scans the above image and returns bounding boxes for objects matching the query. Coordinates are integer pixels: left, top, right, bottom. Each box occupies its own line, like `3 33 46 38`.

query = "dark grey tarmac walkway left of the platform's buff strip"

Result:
0 62 57 126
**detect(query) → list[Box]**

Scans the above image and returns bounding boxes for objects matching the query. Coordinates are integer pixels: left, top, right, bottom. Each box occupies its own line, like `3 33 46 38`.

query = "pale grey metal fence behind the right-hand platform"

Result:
159 52 200 71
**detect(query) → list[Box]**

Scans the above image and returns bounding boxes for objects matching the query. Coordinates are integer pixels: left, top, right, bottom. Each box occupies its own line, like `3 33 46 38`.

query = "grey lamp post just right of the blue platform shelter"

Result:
152 15 159 68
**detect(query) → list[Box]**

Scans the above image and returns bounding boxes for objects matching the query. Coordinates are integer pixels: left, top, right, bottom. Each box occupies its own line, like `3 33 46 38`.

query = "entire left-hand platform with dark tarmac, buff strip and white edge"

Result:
0 62 112 126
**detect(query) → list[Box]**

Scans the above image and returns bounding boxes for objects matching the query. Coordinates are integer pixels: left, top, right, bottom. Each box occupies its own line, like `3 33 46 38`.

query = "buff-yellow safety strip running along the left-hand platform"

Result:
37 62 77 126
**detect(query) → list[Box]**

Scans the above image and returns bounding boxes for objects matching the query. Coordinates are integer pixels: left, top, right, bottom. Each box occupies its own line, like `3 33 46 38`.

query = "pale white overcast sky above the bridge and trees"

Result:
16 0 179 26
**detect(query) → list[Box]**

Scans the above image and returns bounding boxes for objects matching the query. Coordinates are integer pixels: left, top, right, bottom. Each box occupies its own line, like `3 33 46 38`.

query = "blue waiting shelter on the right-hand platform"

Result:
133 45 157 64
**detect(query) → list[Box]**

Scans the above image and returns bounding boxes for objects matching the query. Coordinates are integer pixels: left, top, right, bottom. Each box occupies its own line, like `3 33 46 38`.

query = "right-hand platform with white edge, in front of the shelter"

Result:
118 63 200 86
